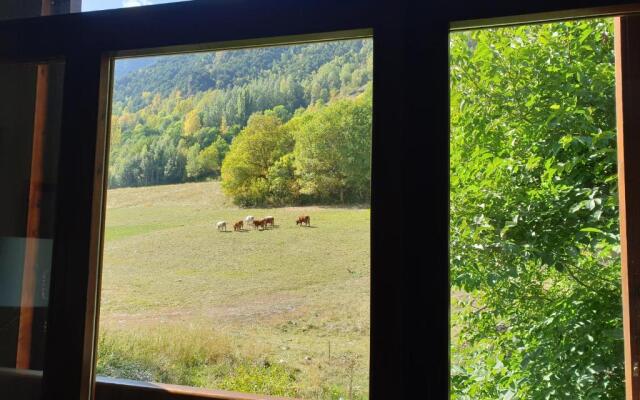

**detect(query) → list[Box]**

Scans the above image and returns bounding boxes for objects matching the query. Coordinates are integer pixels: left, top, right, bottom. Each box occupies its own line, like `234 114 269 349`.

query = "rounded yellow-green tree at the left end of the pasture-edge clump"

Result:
222 113 293 205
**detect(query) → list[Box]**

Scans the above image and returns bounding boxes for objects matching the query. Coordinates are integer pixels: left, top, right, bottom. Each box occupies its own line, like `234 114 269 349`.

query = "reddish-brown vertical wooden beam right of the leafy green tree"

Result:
614 17 640 400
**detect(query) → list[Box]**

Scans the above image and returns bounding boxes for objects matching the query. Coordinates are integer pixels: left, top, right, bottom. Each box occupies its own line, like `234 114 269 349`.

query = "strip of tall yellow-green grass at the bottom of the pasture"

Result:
97 326 367 400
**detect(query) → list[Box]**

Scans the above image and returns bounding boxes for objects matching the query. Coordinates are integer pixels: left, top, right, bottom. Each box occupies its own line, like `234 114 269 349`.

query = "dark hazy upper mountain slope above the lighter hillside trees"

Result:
114 40 373 110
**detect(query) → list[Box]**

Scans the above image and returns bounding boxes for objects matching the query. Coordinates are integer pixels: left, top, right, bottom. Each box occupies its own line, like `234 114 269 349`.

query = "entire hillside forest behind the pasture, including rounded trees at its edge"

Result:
109 40 373 205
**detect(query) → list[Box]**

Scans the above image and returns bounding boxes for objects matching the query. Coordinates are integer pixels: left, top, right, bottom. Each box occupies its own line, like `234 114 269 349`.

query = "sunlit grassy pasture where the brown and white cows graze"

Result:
98 182 370 399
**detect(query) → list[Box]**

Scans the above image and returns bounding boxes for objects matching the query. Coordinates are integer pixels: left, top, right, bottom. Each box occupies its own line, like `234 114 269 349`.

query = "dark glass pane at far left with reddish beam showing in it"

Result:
0 62 64 399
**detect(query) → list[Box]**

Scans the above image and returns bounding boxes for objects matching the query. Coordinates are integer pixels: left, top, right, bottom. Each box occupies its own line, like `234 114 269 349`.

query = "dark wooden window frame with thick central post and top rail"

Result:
0 0 640 400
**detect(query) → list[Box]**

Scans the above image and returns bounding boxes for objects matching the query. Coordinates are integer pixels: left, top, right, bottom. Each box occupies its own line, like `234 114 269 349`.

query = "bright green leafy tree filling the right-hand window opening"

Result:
450 20 624 399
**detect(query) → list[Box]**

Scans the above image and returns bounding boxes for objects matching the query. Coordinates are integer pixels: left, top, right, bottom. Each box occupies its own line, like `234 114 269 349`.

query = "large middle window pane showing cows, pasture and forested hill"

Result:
97 39 373 399
